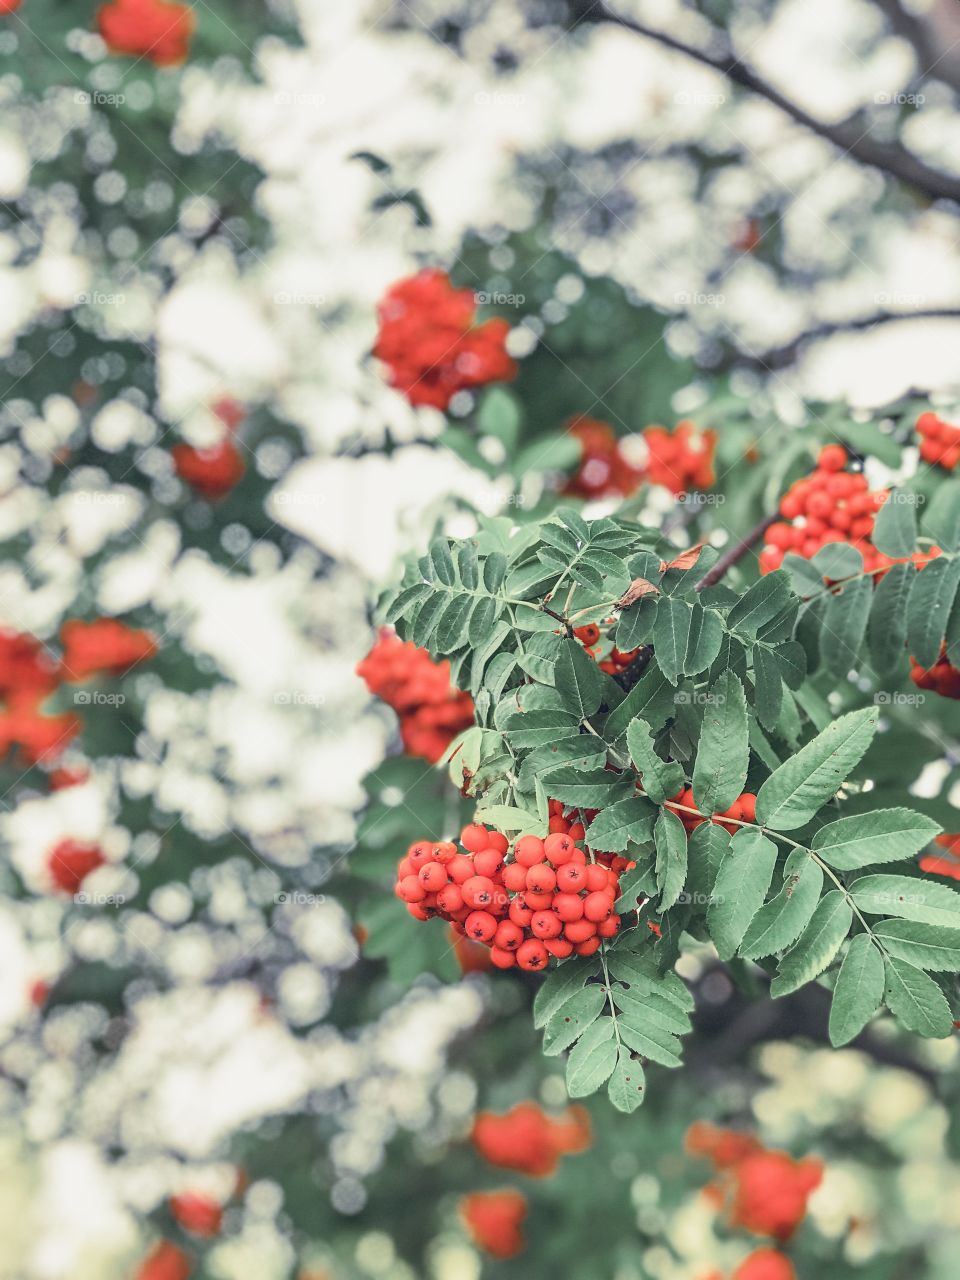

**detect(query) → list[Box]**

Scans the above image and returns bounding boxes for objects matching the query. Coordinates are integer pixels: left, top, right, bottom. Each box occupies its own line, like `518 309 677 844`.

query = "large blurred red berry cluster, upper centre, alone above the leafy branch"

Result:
374 268 517 410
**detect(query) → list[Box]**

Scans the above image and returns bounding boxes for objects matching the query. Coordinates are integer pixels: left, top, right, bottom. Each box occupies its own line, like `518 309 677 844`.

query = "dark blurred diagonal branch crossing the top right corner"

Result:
571 0 960 204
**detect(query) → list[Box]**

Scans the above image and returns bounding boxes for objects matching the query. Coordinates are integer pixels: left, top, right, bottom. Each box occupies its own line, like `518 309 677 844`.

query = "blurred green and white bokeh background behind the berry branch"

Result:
0 0 960 1280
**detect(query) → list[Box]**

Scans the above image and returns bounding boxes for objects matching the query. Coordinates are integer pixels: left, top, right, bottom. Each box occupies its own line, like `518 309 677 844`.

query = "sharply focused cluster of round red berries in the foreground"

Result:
394 800 630 972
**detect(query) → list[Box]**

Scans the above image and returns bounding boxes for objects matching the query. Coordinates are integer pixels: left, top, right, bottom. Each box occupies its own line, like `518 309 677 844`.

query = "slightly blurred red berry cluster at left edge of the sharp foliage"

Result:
357 627 474 764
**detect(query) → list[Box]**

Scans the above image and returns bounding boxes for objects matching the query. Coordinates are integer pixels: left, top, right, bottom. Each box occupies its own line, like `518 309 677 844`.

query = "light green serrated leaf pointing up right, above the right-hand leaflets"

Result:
756 707 878 831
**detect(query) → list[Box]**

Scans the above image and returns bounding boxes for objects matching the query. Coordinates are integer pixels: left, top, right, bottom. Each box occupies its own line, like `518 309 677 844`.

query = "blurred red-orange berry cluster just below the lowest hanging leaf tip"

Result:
470 1102 591 1178
